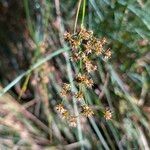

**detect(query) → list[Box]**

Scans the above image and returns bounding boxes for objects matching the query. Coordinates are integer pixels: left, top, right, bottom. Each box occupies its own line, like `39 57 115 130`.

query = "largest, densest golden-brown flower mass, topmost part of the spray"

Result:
64 28 111 65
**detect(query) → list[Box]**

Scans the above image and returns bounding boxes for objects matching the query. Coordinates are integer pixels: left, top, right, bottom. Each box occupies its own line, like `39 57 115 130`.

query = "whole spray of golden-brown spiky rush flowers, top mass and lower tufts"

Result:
56 28 111 127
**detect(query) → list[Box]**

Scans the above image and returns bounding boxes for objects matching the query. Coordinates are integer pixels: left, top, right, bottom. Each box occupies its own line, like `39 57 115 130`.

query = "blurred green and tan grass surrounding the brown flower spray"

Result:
0 0 150 150
